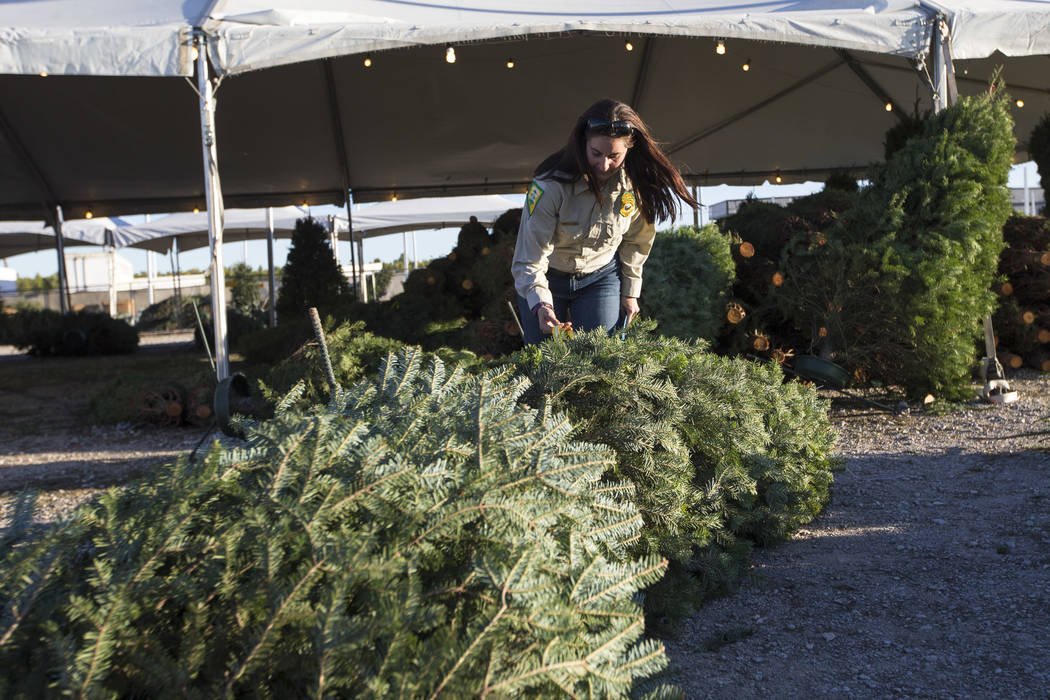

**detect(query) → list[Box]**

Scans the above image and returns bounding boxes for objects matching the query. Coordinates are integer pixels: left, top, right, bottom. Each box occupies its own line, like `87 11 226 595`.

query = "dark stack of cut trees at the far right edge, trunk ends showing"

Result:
992 216 1050 372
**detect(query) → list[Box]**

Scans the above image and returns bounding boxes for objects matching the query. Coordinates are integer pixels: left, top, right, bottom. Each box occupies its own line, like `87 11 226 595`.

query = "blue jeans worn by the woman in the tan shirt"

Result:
518 257 621 345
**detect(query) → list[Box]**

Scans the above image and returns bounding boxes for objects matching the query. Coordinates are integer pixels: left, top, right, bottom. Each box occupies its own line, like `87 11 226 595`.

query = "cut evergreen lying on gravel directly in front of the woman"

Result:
499 321 835 616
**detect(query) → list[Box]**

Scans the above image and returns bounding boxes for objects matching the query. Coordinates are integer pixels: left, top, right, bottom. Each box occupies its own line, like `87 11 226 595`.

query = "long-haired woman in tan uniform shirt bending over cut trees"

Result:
510 100 697 343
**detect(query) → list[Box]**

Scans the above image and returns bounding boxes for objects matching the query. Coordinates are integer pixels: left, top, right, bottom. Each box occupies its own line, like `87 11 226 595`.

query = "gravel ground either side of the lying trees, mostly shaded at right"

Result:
0 352 1050 699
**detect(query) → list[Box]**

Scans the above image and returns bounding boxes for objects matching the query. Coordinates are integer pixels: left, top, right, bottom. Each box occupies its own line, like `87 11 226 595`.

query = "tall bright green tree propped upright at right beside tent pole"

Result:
777 88 1014 400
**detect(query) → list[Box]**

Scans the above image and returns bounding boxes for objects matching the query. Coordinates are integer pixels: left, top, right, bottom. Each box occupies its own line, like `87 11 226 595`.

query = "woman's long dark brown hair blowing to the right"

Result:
534 98 699 224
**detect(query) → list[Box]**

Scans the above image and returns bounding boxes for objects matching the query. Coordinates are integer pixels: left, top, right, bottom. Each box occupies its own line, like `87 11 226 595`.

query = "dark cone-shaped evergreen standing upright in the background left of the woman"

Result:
277 216 350 318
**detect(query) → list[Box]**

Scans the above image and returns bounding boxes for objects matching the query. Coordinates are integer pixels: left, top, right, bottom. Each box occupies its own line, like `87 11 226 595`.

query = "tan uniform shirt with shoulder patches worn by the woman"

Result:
510 168 656 309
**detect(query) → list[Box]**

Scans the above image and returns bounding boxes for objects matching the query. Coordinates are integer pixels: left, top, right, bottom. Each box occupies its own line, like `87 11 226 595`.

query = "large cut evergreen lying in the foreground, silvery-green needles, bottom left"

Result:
0 351 669 698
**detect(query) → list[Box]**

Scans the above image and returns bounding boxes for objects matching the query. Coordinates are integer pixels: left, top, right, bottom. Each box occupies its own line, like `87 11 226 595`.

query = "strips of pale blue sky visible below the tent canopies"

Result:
0 162 1040 277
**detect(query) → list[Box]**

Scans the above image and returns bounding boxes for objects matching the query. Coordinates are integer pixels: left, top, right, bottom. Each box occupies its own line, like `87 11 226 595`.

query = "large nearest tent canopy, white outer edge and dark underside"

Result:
0 0 1050 218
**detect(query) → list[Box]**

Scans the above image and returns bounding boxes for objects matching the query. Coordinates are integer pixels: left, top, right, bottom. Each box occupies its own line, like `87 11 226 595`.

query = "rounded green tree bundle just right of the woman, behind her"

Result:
639 224 735 341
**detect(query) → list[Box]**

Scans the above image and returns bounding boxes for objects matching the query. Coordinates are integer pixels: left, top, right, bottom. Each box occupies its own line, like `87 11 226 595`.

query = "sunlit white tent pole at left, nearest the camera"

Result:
195 33 230 381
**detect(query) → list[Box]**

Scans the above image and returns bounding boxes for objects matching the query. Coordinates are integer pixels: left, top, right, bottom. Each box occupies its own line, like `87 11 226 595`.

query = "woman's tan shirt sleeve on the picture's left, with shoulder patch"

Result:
510 181 561 309
